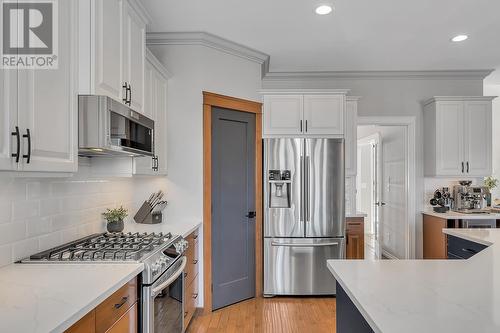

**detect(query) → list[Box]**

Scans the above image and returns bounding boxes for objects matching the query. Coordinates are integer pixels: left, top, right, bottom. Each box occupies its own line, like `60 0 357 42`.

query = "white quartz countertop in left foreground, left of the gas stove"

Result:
0 263 144 333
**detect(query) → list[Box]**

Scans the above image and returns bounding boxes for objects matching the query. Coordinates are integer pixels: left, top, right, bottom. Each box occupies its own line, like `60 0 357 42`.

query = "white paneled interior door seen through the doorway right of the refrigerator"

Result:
377 126 408 259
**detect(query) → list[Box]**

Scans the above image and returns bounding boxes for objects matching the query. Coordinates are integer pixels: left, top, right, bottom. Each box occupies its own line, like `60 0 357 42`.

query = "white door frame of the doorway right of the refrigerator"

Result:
357 116 421 259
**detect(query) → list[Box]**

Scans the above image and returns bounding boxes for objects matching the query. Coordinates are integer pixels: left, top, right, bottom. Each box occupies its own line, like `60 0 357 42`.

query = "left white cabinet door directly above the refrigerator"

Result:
263 95 304 135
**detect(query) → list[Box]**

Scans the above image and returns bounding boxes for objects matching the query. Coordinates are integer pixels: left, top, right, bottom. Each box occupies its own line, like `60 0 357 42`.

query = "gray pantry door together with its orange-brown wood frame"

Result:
203 92 262 313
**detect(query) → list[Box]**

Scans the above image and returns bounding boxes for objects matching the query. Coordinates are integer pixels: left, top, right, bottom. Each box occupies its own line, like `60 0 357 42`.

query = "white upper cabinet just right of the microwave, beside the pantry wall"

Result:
133 51 169 175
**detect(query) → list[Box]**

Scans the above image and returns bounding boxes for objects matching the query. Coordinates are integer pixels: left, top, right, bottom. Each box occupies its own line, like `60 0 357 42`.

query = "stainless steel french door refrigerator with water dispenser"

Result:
264 138 345 296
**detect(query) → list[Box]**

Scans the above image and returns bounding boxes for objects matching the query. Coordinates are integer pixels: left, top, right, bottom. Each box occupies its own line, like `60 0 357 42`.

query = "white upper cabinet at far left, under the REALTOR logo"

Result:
0 0 78 172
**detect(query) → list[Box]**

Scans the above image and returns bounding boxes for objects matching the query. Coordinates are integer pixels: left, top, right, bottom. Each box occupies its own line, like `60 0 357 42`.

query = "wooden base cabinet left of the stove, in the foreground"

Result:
66 278 138 333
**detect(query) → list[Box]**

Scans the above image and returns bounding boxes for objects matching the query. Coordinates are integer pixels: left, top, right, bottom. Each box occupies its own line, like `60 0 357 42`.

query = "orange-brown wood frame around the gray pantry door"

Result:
203 91 263 314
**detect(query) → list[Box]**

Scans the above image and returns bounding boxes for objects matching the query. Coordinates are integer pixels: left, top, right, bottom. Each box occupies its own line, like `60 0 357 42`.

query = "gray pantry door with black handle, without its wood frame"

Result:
212 108 255 310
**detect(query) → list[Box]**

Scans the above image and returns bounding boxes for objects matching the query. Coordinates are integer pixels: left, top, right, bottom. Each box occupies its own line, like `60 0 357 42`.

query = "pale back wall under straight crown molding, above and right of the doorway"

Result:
262 78 483 258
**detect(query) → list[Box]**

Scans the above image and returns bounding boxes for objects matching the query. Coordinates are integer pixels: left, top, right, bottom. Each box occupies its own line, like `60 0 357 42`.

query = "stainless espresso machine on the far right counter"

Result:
453 181 491 214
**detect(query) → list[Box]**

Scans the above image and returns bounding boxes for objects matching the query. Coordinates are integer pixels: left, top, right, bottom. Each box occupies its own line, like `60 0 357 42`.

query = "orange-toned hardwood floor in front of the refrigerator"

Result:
187 297 336 333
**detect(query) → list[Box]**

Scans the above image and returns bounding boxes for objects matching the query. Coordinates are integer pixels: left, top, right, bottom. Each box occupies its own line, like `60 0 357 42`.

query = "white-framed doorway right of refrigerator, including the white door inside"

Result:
356 117 415 259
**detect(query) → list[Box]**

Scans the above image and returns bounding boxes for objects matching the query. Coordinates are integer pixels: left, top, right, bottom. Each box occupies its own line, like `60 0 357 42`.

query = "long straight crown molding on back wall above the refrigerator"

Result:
263 69 494 81
